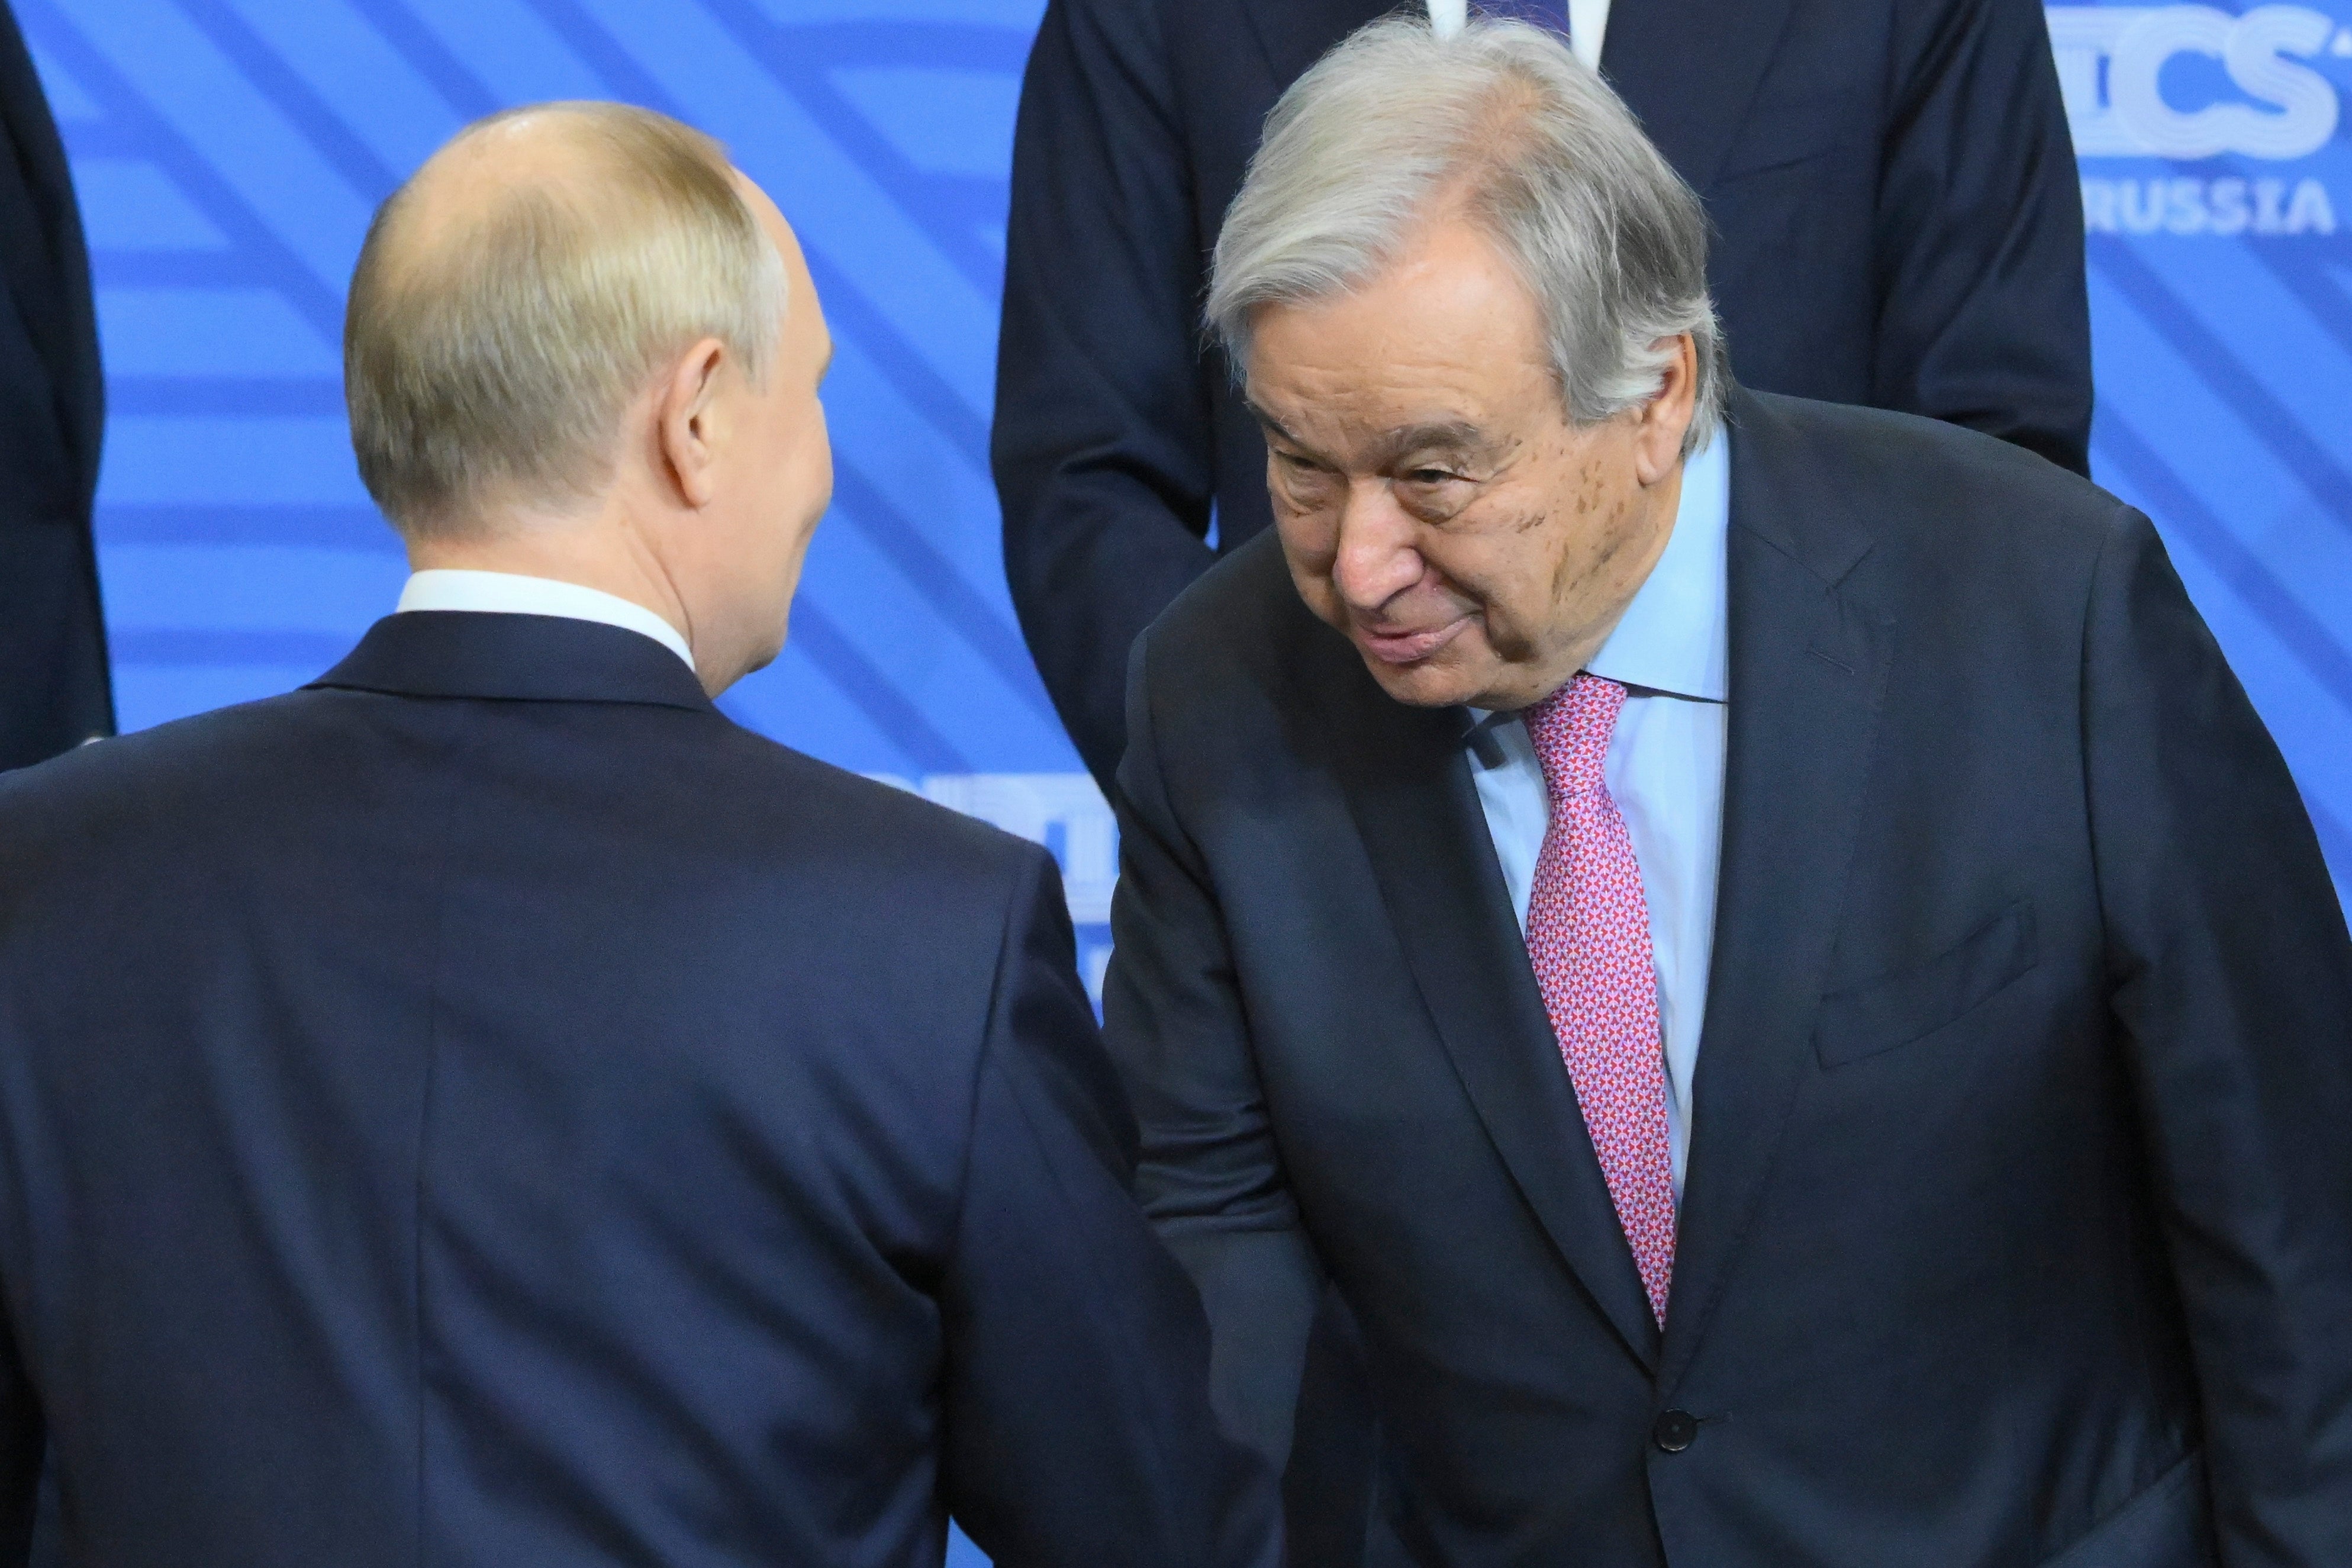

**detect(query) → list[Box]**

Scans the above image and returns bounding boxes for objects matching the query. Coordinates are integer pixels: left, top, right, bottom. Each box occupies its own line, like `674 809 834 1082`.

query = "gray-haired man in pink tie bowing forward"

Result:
1106 19 2352 1568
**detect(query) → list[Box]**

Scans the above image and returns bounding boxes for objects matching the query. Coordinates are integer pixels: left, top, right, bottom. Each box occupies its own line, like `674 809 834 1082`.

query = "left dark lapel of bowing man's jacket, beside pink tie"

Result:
1329 649 1658 1368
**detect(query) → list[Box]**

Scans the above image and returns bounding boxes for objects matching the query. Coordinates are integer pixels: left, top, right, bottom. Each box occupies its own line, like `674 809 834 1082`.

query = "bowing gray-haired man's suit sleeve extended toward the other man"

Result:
1103 635 1322 1467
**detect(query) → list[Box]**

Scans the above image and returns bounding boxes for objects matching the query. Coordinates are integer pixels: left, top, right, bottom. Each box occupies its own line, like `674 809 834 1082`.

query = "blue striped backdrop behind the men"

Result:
17 0 2352 1551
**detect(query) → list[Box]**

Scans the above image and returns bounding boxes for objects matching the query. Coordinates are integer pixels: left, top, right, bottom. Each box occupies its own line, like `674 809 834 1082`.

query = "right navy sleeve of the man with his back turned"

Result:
943 853 1282 1568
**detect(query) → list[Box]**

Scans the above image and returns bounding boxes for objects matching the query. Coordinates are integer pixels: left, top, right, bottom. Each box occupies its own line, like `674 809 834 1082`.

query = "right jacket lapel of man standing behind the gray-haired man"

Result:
1602 0 1790 191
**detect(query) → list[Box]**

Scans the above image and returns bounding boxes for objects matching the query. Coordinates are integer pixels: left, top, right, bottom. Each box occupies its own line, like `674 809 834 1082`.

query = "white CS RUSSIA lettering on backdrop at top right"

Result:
2048 5 2352 235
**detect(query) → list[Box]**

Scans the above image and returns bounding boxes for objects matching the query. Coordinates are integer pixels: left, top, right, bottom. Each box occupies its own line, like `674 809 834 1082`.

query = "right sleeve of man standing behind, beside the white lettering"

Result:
1872 0 2091 475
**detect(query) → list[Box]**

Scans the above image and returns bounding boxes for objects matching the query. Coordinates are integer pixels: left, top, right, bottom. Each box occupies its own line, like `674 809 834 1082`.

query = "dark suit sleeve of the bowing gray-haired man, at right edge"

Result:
2084 512 2352 1568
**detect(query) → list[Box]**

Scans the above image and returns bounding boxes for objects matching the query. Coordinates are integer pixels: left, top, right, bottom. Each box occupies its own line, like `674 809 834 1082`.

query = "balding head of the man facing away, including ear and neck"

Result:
343 104 833 693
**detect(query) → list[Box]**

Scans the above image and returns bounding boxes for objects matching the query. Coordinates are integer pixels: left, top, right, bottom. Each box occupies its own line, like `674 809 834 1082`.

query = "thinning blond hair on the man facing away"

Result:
343 104 785 541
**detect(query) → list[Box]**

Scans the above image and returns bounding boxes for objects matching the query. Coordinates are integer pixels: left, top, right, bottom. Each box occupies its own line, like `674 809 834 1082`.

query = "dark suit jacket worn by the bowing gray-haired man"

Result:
1106 392 2352 1568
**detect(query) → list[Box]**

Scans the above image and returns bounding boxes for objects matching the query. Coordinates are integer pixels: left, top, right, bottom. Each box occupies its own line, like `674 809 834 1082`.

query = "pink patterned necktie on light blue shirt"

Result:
1526 675 1674 1324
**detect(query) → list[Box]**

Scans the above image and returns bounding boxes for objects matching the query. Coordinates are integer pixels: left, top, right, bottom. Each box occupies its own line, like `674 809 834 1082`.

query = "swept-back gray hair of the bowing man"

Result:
1207 17 1729 456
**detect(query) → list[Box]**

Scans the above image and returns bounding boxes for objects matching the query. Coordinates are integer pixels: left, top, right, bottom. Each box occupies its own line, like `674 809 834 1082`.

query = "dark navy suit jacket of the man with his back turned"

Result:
0 614 1277 1568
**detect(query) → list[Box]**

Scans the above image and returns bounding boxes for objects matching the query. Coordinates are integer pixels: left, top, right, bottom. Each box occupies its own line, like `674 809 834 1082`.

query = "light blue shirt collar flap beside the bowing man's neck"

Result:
1585 435 1731 703
